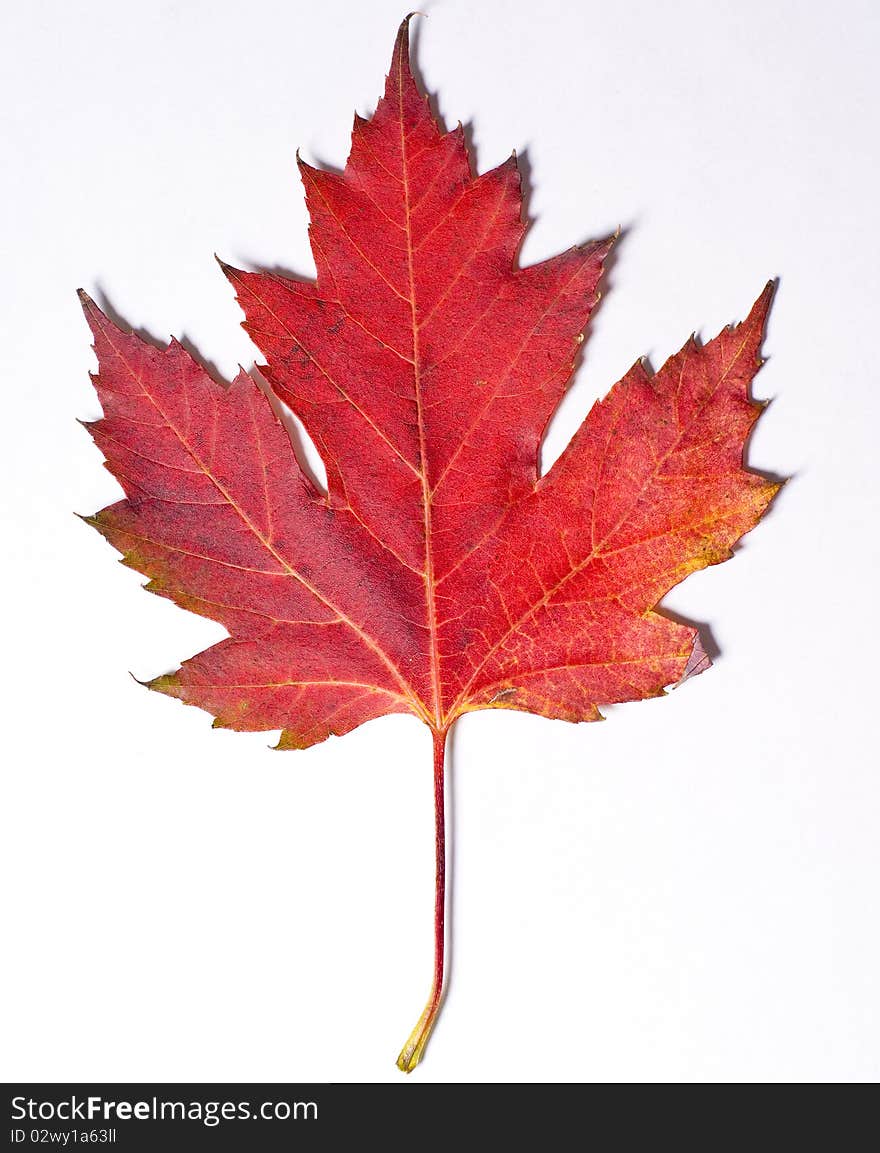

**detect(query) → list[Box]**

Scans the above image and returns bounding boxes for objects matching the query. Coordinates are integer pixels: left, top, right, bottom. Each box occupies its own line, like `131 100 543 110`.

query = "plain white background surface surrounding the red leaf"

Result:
0 0 880 1084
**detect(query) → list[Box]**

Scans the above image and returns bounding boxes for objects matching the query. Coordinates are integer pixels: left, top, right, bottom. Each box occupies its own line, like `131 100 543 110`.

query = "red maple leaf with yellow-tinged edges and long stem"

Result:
83 20 777 1070
